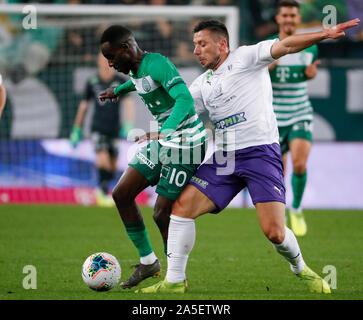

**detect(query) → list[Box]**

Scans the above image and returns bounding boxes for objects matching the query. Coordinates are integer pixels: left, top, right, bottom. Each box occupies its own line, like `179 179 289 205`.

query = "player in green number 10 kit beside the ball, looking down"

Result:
99 25 207 288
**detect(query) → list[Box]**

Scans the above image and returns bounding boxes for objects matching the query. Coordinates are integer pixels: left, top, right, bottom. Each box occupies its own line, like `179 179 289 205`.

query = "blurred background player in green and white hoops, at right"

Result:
269 0 320 236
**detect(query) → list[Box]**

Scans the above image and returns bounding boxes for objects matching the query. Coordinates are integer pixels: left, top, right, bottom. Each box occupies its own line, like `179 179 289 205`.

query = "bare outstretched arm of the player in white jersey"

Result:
271 18 360 59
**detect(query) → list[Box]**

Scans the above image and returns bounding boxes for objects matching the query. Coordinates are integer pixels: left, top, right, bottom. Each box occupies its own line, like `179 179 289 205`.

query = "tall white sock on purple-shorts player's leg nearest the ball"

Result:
166 214 195 283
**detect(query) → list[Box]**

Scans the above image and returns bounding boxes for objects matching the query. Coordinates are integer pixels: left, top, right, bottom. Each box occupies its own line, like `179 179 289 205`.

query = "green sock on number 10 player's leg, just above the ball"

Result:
124 221 153 257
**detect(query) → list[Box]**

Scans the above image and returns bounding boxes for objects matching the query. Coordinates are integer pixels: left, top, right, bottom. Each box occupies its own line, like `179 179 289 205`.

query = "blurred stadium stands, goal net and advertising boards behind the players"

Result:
0 0 363 208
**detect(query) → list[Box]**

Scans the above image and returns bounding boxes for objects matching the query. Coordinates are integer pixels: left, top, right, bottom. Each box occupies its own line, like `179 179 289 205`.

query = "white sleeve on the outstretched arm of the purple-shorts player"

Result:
237 39 279 68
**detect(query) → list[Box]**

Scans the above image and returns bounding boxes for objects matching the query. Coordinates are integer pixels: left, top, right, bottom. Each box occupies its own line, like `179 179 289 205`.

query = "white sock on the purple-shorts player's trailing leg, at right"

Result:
273 226 305 274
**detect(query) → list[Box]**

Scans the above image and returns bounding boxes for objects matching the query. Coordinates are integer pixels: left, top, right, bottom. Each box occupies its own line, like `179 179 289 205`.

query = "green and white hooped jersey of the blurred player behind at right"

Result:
270 35 318 127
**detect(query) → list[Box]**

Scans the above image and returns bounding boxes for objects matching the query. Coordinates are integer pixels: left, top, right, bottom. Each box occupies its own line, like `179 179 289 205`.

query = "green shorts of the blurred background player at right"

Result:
279 120 313 154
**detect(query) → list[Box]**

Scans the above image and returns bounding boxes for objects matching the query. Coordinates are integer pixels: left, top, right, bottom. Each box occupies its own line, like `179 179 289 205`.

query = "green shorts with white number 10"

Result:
129 140 206 200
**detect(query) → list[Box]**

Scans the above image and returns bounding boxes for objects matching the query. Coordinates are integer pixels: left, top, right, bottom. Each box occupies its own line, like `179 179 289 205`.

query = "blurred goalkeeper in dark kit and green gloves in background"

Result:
70 53 134 206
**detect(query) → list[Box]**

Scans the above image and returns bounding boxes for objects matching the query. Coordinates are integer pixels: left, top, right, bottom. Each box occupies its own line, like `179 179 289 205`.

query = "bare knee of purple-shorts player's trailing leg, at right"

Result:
255 201 285 243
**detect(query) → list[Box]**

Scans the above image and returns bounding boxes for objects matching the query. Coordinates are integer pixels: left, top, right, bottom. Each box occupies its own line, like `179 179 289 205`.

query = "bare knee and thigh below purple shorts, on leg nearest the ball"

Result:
172 184 217 219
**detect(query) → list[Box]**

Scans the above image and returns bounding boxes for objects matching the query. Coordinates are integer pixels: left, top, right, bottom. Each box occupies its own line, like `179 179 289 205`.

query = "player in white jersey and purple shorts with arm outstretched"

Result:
137 19 359 293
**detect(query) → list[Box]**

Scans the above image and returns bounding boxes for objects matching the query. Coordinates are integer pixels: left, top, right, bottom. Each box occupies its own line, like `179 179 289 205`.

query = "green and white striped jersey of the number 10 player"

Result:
129 53 207 149
